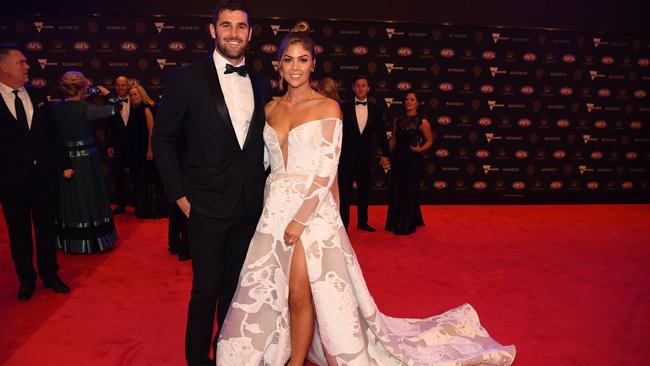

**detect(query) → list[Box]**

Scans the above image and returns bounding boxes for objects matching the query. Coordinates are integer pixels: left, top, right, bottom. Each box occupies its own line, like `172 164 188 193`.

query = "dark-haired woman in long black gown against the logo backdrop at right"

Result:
386 92 433 235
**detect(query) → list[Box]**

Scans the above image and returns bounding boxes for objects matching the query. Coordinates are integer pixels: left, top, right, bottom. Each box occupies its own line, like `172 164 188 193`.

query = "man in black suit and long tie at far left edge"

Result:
0 44 74 301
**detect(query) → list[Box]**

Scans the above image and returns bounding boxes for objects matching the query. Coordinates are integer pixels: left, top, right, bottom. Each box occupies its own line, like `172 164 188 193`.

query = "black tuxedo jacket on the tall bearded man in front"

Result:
152 56 271 218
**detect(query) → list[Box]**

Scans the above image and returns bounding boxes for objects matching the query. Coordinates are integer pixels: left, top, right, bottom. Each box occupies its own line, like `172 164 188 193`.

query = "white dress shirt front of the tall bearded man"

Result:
213 50 255 148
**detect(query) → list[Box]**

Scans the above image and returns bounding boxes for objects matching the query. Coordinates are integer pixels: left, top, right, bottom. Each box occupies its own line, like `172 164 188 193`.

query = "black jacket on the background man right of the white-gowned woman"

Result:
339 100 389 169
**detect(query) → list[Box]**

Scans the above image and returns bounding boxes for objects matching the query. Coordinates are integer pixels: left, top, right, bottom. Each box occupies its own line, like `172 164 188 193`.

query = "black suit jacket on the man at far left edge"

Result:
0 87 72 200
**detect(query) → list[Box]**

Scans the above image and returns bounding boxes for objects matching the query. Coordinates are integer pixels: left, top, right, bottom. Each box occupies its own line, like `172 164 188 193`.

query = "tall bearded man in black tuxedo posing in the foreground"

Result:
153 0 271 365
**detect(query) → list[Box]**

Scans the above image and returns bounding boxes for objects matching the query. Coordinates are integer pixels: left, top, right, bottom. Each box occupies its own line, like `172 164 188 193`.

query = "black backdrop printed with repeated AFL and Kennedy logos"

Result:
0 16 650 202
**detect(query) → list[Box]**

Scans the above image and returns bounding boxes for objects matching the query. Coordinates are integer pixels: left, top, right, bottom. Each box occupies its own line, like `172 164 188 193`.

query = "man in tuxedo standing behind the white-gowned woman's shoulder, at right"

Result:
338 76 390 232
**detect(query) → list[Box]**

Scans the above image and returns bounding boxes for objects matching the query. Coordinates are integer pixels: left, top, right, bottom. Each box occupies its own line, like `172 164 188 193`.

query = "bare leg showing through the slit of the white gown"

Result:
289 241 314 366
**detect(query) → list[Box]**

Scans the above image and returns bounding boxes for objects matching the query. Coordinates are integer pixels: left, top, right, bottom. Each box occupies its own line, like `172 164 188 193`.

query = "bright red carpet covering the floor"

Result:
0 205 650 366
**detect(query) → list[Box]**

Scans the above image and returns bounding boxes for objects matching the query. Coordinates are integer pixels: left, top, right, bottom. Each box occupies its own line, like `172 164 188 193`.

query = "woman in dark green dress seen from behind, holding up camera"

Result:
52 71 119 253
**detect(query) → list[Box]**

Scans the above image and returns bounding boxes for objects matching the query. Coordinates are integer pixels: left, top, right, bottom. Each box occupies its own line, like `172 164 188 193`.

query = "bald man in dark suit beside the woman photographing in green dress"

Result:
106 76 148 215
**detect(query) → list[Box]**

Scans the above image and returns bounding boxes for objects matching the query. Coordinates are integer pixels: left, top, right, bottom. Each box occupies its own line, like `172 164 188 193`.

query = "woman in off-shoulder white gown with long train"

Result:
216 25 515 366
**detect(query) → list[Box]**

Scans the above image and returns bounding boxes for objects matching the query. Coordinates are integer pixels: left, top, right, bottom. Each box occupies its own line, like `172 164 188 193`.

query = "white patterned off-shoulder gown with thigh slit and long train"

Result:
217 118 515 366
